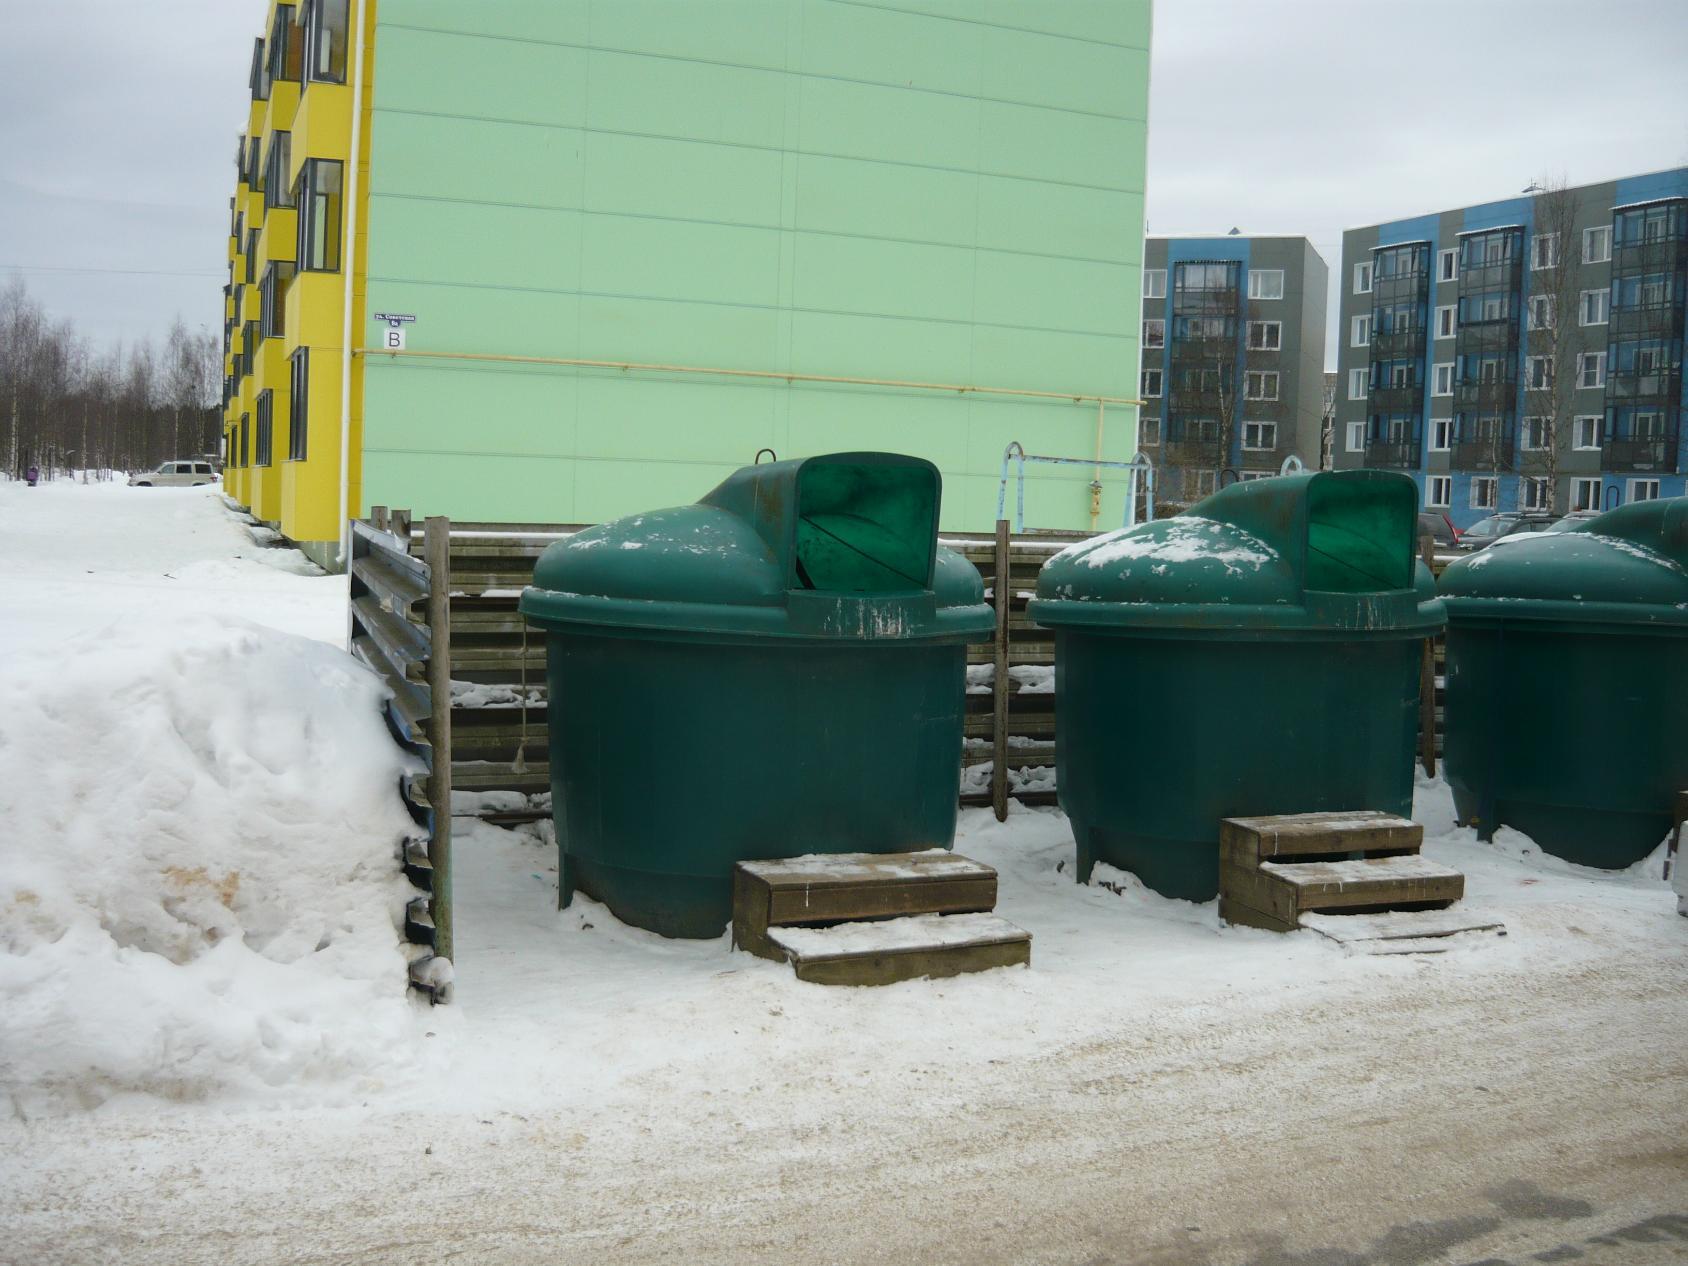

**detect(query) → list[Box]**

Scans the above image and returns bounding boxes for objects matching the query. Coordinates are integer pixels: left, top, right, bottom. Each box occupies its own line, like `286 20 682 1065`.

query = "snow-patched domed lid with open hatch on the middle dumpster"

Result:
1028 471 1443 636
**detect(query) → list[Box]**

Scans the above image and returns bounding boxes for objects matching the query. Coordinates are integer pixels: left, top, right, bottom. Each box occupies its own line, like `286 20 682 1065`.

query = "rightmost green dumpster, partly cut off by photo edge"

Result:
1440 498 1688 869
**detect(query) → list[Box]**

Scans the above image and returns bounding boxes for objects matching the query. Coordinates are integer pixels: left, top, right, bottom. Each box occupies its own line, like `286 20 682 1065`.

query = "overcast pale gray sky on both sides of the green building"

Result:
0 0 1688 366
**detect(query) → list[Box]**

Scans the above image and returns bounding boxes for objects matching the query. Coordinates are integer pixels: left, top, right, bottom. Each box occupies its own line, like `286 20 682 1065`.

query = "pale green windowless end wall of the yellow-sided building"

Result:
363 0 1150 530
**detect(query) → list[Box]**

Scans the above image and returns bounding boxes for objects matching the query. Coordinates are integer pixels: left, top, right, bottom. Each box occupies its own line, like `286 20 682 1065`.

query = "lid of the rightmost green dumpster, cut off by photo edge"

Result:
1438 496 1688 626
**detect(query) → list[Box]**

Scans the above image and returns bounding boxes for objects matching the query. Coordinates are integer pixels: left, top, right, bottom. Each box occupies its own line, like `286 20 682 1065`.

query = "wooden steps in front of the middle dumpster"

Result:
1219 810 1504 952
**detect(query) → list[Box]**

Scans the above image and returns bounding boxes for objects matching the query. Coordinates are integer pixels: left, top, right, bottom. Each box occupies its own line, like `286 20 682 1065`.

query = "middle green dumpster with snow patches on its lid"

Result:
1028 471 1442 901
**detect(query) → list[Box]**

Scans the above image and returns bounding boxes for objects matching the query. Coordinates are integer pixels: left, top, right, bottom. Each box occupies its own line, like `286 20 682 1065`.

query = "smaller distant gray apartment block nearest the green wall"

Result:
1138 233 1330 503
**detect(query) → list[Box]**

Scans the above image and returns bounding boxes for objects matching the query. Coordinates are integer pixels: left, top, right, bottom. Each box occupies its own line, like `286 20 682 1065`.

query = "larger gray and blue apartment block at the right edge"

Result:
1334 169 1688 527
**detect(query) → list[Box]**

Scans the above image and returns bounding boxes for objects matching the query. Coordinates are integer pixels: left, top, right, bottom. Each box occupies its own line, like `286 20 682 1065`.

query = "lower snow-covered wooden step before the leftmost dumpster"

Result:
768 913 1031 984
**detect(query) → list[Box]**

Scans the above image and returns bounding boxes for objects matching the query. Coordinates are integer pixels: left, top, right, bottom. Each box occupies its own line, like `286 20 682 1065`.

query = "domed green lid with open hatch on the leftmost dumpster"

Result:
522 452 994 641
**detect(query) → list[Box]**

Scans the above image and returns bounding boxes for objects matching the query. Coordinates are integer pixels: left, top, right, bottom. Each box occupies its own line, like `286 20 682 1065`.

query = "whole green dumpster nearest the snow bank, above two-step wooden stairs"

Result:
520 452 994 937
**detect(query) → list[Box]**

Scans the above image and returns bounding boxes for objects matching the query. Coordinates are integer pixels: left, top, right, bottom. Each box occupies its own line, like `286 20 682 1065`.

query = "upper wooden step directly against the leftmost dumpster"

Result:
733 849 996 957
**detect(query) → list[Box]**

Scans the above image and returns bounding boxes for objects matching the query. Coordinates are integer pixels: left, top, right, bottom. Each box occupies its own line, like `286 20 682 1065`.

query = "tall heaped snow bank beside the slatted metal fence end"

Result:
0 614 422 1107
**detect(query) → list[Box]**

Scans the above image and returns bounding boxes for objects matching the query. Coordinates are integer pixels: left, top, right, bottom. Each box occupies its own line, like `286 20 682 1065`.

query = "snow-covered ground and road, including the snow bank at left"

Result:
0 484 1688 1266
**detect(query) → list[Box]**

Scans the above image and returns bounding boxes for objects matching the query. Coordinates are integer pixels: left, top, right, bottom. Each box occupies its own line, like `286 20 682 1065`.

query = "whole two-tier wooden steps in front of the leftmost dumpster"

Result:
733 849 1031 984
